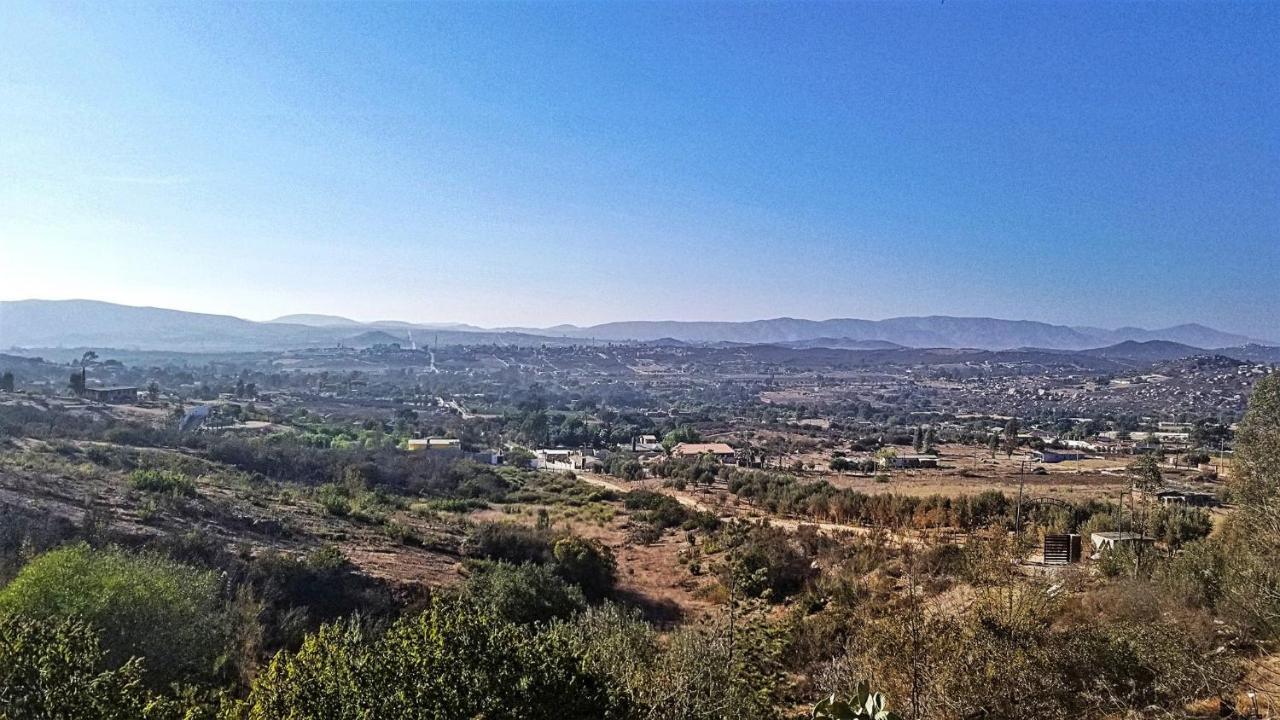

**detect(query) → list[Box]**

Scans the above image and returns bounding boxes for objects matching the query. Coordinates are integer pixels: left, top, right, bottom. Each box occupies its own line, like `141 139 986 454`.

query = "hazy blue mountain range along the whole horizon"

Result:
0 300 1274 359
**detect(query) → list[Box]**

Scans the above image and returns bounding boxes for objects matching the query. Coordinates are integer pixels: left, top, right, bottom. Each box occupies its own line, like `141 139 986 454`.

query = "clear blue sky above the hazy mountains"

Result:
0 0 1280 338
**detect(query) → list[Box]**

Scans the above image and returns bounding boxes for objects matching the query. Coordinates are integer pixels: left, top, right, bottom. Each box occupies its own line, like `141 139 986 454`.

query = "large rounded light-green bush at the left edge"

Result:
0 544 225 687
